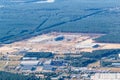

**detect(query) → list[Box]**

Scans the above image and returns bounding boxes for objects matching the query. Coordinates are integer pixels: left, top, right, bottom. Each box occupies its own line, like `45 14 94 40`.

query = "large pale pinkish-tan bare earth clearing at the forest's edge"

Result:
0 32 120 54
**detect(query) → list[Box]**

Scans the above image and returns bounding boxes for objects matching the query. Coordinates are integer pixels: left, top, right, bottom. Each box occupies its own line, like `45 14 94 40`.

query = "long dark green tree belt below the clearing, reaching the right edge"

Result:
65 49 120 67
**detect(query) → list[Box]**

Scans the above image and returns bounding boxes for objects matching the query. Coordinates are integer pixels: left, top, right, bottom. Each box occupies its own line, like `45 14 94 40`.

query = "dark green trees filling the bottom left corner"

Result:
0 71 41 80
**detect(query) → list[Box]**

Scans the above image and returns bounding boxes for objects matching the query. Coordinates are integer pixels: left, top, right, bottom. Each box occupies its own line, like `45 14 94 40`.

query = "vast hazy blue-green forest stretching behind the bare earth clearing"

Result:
0 0 120 43
